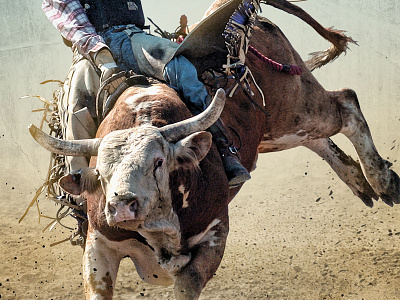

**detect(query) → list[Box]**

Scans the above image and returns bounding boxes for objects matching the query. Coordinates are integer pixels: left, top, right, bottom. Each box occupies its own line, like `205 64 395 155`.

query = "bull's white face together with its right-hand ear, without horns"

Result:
97 126 211 230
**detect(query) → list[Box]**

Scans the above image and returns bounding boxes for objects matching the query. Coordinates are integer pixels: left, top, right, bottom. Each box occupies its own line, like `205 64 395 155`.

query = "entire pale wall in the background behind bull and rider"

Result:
0 0 400 210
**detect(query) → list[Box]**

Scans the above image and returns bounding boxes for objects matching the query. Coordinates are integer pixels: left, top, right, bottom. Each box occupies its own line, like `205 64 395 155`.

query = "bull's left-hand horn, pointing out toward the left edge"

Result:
28 124 101 156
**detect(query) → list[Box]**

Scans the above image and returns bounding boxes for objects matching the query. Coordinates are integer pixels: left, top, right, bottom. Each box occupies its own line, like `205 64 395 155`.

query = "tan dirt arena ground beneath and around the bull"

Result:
0 150 400 300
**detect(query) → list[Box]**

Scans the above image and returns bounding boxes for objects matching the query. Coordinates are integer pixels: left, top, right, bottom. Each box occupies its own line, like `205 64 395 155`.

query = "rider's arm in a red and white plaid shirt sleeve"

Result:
42 0 108 59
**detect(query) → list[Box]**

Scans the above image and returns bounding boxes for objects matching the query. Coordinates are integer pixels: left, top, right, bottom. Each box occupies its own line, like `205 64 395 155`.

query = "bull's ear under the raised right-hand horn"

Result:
174 131 212 168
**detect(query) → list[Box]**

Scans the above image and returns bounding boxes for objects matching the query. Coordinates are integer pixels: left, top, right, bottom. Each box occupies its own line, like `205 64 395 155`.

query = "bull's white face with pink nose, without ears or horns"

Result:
97 127 171 229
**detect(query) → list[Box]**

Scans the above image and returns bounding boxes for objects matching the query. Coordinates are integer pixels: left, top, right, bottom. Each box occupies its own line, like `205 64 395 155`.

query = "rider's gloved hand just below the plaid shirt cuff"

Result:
94 48 124 94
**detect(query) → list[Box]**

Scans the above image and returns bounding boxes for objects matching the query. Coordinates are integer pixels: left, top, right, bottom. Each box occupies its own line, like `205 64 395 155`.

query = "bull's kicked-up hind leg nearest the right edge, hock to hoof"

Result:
333 89 400 206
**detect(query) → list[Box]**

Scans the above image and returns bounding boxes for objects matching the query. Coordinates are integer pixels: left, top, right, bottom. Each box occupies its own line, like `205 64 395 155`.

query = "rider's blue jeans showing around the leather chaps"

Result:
100 26 208 114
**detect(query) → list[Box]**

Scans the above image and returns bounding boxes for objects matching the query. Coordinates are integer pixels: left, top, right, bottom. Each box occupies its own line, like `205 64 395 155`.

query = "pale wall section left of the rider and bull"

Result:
0 0 71 206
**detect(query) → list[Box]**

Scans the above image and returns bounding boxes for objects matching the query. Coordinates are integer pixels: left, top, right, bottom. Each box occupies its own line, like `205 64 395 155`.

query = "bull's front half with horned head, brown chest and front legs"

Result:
30 84 229 299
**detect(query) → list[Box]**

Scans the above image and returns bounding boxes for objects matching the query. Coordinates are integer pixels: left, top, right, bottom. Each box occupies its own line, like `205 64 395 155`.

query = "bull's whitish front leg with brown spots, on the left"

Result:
83 227 122 300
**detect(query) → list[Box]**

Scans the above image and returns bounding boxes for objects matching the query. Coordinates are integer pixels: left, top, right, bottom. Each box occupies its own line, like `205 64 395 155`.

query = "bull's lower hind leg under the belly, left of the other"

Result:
304 138 378 207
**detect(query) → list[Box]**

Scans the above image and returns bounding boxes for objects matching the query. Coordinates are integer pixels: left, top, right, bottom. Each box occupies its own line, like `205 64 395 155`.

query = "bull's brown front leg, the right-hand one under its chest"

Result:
174 215 228 300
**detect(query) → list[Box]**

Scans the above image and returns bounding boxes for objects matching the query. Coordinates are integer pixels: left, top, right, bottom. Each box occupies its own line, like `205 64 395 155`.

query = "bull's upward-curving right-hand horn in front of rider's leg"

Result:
160 89 226 142
